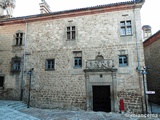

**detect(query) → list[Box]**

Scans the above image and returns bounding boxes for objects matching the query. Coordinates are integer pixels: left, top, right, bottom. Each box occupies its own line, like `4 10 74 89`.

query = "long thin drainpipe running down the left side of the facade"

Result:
20 18 28 101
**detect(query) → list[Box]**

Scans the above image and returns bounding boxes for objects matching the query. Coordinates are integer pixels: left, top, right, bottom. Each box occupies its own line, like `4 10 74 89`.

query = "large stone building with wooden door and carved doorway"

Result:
0 0 144 113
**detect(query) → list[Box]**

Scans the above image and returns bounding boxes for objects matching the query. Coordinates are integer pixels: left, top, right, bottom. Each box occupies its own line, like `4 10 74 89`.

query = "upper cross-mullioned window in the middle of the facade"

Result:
67 26 76 40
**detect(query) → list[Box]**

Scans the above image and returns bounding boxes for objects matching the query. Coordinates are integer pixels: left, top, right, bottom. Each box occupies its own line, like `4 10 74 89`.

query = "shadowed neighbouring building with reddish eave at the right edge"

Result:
143 30 160 105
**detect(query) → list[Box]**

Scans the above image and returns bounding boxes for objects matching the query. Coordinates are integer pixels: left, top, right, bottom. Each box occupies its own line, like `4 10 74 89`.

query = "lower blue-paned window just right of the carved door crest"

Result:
119 55 128 67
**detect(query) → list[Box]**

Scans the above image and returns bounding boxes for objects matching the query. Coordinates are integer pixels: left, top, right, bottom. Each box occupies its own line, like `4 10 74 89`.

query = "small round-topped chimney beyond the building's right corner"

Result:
142 25 152 40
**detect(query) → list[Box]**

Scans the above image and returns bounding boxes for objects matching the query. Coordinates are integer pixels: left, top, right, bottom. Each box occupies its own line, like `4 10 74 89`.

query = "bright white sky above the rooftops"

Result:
13 0 160 34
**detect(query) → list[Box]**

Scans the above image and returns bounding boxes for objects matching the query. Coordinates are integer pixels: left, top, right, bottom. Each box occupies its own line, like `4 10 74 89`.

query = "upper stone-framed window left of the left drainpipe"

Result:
14 30 24 46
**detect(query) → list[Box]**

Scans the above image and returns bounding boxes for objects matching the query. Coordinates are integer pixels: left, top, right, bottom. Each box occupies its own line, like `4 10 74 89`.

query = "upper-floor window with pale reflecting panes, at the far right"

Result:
120 21 132 35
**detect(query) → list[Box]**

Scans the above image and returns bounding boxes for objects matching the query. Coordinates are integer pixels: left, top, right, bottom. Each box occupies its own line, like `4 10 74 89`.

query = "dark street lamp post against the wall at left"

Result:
27 68 34 108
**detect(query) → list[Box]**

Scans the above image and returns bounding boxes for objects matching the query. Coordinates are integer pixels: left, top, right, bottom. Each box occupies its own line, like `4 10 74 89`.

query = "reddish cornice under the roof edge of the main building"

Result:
0 1 143 26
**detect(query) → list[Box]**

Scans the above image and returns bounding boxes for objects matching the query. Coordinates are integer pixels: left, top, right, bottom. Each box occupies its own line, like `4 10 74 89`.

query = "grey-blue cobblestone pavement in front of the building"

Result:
0 100 160 120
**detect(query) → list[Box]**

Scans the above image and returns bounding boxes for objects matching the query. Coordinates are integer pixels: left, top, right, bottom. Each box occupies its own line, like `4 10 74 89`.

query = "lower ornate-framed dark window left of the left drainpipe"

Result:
11 56 21 72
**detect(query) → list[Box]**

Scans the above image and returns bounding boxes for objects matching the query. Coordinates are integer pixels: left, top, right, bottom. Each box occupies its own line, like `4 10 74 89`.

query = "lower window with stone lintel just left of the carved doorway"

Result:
73 51 82 68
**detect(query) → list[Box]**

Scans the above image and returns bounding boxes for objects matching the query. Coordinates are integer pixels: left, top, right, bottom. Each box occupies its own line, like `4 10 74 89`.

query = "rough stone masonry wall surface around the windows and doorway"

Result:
0 9 144 113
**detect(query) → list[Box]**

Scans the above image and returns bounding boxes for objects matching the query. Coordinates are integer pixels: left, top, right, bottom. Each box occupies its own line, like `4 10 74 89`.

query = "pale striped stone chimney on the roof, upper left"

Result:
39 0 51 14
